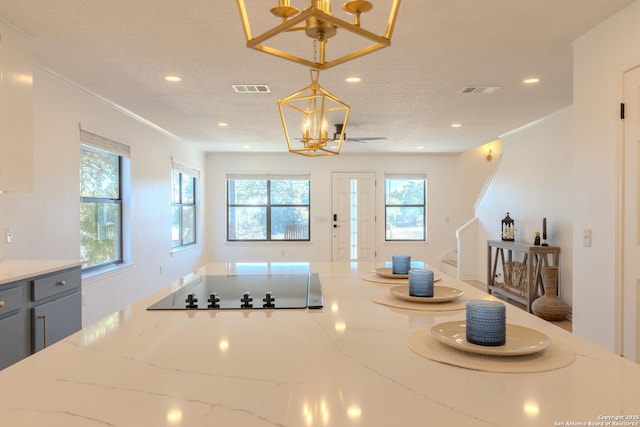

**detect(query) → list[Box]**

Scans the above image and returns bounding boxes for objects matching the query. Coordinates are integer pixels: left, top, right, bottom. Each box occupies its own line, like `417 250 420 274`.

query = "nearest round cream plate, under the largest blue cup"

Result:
431 321 551 356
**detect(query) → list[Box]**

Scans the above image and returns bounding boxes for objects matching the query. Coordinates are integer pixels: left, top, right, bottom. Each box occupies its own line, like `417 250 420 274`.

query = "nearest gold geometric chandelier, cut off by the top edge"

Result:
237 0 400 70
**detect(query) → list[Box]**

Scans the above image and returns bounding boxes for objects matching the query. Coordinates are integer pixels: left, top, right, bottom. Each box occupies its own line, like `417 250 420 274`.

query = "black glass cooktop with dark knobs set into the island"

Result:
147 273 324 310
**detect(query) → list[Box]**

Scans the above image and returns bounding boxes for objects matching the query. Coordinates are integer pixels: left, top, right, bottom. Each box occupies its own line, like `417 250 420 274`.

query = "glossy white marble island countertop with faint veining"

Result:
0 263 640 427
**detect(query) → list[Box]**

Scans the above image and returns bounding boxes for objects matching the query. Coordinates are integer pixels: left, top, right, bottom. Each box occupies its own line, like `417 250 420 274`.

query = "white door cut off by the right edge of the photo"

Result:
621 67 640 363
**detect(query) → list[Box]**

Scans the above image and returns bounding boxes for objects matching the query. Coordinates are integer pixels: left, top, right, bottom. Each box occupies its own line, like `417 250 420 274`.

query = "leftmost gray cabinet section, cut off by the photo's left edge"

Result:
0 281 31 369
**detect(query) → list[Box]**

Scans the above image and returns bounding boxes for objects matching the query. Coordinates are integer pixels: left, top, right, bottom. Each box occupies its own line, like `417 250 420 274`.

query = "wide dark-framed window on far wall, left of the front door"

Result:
227 176 310 241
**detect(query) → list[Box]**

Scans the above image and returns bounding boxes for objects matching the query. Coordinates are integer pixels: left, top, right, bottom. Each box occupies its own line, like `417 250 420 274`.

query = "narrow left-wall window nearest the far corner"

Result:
171 163 200 249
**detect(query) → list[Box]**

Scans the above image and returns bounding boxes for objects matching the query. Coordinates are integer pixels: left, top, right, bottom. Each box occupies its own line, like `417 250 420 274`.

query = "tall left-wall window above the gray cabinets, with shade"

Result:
80 130 129 271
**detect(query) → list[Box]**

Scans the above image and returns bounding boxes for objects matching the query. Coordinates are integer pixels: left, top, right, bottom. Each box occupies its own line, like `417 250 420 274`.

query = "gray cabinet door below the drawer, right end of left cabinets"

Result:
31 290 82 353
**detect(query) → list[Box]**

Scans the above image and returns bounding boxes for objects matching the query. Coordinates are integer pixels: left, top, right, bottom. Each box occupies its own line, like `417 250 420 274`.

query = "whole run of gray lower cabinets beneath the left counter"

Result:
0 267 82 369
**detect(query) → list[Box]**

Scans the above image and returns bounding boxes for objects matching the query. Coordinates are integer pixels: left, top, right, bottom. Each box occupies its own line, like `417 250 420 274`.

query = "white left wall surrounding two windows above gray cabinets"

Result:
0 67 205 326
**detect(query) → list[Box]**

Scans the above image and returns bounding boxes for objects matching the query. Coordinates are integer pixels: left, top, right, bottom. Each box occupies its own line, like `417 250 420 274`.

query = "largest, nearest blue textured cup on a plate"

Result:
466 300 507 346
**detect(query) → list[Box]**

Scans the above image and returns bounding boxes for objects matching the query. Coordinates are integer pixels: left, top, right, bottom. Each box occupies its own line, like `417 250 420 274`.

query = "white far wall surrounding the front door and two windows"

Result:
206 150 490 265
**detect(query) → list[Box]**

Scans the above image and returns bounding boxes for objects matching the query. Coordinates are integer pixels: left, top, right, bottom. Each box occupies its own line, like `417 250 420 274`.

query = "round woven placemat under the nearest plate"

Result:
408 329 576 374
